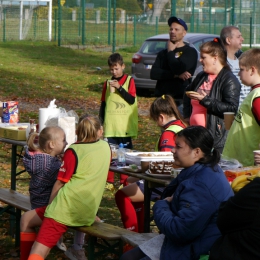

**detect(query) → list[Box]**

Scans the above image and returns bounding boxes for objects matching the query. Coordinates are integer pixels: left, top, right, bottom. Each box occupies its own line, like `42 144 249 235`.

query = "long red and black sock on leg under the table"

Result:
115 190 138 232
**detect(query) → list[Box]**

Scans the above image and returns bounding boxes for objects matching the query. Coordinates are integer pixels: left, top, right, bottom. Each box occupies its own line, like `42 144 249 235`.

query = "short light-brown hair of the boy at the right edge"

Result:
239 48 260 74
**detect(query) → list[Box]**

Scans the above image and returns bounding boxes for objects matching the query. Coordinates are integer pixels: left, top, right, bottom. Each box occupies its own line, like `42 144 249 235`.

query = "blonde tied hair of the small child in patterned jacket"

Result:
27 126 64 154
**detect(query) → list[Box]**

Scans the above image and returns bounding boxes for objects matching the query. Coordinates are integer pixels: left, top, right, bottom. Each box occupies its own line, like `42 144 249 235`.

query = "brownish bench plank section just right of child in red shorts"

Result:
75 222 133 240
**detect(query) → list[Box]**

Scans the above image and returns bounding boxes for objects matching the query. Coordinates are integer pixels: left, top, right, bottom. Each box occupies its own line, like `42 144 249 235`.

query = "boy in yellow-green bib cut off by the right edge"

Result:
223 48 260 166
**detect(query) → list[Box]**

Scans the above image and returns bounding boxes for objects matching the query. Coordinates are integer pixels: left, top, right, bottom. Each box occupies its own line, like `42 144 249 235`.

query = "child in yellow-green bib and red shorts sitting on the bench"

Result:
21 116 111 259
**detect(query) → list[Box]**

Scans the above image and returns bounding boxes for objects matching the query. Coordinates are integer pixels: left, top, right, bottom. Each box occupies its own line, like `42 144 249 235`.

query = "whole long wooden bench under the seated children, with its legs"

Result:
0 188 160 260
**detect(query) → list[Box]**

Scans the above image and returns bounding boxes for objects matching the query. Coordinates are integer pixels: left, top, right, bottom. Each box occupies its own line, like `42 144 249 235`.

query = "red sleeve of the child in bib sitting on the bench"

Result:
57 149 76 182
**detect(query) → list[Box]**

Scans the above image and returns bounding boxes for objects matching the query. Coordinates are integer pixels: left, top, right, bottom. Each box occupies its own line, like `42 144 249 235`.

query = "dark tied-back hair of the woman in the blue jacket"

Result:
176 126 220 168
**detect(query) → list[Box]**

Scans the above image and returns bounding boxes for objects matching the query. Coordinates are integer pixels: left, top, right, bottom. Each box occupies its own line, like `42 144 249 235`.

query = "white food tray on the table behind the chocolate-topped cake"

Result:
125 152 173 166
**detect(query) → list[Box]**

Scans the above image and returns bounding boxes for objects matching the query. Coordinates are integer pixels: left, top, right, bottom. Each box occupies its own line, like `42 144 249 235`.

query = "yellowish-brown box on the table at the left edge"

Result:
0 125 27 141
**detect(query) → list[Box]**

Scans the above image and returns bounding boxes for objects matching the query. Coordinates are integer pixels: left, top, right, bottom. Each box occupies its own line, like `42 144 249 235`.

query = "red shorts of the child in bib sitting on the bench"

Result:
36 217 68 248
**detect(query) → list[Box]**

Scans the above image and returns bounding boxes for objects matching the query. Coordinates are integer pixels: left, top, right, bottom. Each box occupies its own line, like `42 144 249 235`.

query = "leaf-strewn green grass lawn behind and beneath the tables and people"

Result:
0 42 160 259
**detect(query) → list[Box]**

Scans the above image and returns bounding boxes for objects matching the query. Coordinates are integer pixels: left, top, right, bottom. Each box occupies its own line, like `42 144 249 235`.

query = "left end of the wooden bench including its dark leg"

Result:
0 188 31 246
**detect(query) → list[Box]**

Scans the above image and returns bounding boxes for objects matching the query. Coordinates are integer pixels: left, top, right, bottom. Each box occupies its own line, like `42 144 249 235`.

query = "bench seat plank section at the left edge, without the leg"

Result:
0 188 31 211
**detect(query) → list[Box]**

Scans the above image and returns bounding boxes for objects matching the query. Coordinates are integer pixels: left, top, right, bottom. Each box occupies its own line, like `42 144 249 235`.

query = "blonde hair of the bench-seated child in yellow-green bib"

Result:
77 114 102 143
